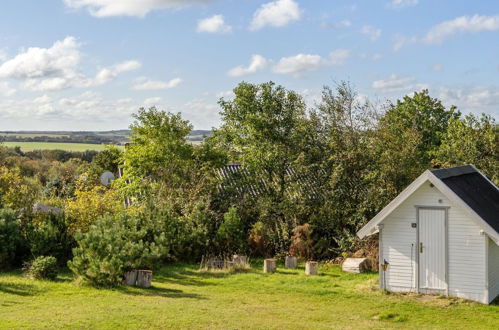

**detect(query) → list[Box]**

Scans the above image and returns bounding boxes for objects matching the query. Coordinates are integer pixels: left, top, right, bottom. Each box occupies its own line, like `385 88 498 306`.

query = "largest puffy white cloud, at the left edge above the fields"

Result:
0 36 141 91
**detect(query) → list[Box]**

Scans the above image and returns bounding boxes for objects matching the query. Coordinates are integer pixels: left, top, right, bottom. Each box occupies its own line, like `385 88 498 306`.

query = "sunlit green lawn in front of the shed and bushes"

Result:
0 260 499 329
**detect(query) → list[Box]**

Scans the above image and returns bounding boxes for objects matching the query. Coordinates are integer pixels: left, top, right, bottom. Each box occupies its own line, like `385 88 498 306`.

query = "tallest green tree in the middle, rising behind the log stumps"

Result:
214 82 307 253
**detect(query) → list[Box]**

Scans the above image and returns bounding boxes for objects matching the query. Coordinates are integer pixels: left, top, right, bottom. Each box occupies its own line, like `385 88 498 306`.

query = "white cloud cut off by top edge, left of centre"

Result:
64 0 214 17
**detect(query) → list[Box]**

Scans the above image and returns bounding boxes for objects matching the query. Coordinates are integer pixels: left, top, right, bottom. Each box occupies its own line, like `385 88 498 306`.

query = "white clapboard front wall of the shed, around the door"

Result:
380 182 486 302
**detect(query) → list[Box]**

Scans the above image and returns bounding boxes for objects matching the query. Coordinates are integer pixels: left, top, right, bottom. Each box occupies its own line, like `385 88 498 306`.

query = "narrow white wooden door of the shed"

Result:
418 208 447 293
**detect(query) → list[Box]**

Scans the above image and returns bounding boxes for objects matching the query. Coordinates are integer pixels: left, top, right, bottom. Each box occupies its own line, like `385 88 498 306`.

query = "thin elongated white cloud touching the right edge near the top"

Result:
423 15 499 44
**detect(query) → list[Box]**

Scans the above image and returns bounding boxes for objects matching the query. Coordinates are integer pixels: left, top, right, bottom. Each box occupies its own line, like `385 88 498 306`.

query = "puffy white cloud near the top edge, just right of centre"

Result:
250 0 302 31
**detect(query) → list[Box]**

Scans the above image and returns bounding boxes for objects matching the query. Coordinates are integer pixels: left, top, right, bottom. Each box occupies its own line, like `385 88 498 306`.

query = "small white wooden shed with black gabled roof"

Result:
357 165 499 304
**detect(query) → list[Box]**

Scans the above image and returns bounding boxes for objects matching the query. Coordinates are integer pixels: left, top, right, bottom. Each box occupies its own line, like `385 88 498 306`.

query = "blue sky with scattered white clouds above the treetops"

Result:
0 0 499 130
